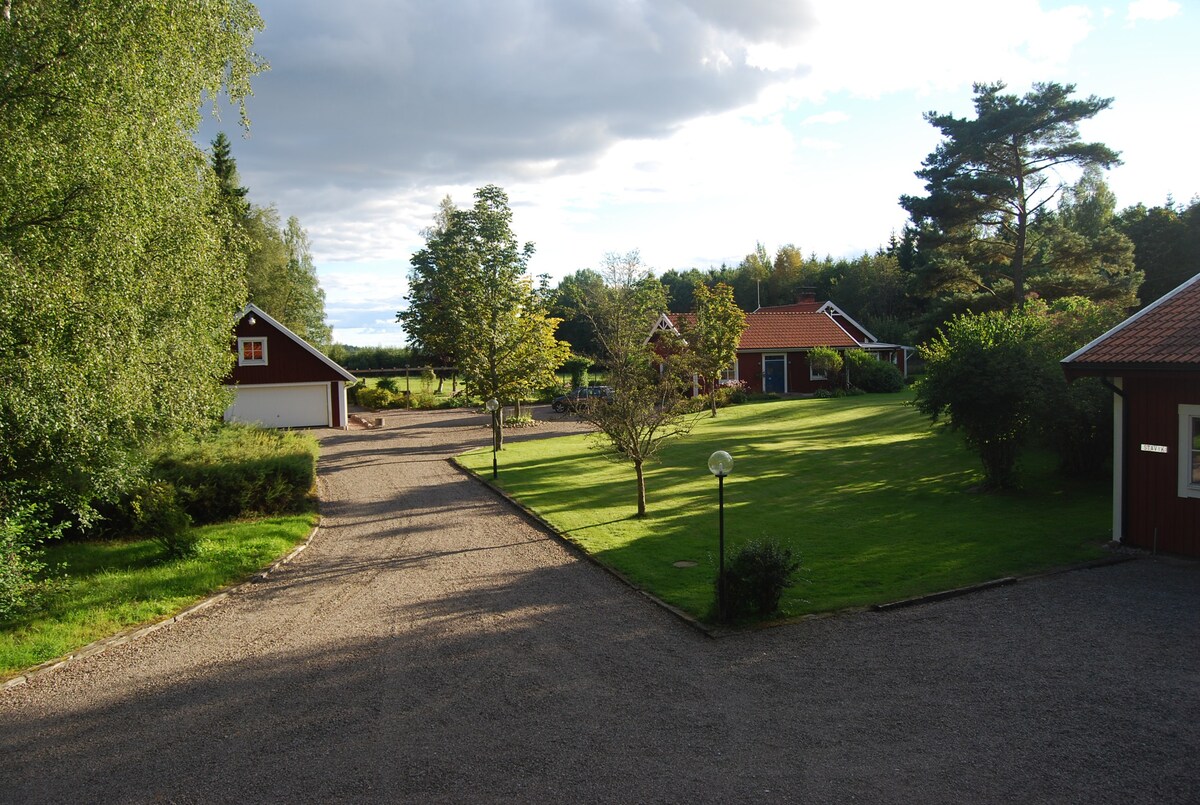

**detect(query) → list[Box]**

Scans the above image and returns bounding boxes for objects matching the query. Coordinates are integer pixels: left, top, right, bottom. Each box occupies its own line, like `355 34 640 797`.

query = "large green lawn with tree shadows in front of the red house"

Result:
460 392 1110 618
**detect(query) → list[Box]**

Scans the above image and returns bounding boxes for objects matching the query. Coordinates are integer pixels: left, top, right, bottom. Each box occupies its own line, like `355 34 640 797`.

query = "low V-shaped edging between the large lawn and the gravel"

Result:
448 457 1138 637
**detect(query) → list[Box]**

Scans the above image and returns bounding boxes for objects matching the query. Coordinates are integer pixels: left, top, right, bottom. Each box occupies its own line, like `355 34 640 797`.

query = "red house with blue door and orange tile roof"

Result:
655 294 912 394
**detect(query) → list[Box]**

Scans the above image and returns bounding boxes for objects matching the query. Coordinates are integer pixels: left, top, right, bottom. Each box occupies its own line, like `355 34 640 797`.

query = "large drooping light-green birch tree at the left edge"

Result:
0 0 264 520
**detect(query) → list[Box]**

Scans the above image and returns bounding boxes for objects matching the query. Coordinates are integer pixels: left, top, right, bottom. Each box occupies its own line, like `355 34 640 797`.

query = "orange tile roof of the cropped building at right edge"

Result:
1062 274 1200 374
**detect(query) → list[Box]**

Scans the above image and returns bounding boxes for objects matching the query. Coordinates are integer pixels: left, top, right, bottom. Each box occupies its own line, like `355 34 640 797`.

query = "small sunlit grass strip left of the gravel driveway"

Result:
0 513 316 679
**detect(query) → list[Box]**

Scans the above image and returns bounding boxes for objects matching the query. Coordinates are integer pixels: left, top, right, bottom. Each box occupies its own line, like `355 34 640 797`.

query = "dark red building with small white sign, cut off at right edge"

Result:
1062 275 1200 557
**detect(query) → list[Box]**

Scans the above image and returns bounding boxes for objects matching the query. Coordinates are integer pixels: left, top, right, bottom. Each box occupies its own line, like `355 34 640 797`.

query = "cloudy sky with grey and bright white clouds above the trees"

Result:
202 0 1200 346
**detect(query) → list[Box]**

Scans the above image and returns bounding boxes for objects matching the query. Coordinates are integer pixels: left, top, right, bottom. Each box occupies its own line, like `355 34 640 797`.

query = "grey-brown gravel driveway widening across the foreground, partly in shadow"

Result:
0 405 1200 803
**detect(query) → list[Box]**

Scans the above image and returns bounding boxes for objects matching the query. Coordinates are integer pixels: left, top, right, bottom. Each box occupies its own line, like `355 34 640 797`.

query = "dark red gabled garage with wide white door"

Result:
224 304 355 428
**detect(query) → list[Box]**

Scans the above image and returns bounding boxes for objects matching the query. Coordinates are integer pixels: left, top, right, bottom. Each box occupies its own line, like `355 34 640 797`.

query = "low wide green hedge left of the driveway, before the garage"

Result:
151 425 317 523
